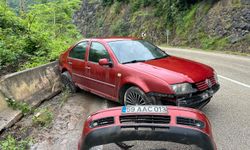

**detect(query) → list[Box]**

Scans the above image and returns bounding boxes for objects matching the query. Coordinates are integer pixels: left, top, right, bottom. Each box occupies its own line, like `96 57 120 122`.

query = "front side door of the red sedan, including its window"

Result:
86 42 116 100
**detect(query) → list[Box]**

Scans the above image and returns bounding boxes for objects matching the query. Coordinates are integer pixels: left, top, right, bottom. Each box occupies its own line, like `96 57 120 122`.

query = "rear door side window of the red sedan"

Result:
69 42 88 60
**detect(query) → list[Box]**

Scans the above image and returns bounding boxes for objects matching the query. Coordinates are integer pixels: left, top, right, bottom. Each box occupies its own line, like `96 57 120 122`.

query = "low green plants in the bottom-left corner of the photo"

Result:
0 135 32 150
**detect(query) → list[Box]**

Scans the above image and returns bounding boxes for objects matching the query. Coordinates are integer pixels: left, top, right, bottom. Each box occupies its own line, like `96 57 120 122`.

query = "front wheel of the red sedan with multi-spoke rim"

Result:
123 86 156 105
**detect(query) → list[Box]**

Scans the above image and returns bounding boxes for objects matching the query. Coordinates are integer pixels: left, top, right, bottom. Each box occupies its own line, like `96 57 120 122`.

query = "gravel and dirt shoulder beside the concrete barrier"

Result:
0 91 107 150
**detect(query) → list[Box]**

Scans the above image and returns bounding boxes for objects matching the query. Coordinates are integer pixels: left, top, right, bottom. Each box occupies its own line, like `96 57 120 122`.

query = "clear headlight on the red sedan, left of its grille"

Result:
171 83 197 95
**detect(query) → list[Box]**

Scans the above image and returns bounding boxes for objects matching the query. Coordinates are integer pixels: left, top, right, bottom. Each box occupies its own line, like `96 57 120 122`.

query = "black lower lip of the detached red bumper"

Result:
78 126 216 150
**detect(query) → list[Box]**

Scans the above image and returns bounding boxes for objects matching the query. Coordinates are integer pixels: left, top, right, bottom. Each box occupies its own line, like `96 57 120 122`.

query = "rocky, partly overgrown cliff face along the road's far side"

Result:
73 0 250 53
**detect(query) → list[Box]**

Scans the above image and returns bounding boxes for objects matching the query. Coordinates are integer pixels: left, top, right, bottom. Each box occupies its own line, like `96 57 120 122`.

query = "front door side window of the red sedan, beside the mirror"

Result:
89 42 110 62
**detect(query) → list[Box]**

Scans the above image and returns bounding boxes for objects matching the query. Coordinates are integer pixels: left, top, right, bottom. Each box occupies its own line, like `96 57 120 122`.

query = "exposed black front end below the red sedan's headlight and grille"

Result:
176 84 220 108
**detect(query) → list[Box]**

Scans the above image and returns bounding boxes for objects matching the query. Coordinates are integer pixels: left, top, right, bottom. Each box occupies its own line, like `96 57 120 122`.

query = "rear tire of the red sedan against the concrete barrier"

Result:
61 71 78 93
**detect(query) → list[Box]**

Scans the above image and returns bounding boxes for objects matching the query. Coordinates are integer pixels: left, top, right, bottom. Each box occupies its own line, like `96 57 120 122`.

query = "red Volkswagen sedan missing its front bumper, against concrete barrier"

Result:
59 38 219 108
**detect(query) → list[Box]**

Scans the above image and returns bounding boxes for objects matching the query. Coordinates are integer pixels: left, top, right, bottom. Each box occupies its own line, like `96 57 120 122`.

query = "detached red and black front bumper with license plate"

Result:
78 105 216 150
